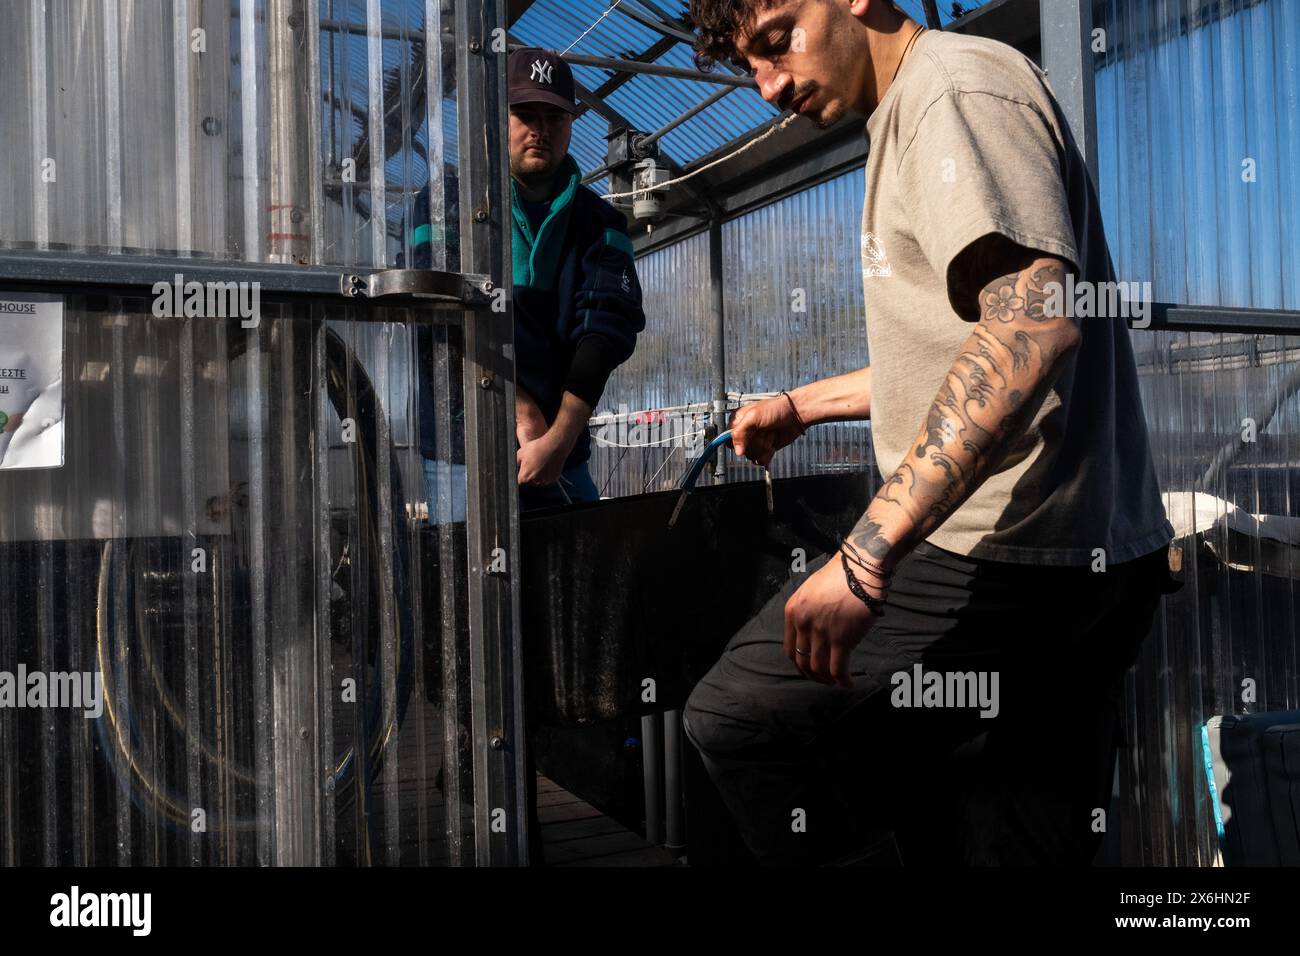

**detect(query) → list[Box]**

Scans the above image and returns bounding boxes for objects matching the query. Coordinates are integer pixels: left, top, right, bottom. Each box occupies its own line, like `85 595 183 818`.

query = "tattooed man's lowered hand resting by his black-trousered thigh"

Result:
783 554 881 688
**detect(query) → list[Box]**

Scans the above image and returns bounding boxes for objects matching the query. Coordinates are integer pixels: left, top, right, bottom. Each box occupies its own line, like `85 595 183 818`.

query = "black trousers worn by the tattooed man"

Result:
684 544 1180 865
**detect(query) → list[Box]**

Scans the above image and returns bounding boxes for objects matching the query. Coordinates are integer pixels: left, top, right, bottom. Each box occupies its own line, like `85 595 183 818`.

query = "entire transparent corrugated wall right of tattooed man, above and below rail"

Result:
1095 0 1300 865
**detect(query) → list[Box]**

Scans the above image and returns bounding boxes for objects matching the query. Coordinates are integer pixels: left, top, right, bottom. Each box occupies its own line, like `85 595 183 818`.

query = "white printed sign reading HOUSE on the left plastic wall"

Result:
0 293 64 470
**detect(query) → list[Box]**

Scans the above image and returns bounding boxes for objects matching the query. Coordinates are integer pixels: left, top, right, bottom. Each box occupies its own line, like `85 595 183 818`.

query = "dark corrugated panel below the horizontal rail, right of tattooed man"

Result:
1121 332 1300 865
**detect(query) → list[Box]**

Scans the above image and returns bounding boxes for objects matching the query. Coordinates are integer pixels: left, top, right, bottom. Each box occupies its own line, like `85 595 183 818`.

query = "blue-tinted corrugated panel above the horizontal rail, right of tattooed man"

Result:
1096 0 1300 310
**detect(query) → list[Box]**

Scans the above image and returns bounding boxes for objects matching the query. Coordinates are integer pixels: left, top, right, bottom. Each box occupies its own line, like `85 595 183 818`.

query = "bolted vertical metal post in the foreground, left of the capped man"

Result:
455 0 528 865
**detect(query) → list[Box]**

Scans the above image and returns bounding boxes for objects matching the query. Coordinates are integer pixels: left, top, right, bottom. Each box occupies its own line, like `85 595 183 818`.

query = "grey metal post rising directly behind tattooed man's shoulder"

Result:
1039 0 1097 183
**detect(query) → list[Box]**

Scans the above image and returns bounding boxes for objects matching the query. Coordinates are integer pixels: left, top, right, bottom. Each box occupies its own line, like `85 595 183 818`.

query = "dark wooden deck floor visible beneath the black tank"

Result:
537 774 677 866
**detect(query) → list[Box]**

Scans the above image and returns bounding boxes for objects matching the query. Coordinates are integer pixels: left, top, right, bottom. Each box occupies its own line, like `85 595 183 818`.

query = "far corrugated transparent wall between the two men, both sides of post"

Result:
592 169 875 497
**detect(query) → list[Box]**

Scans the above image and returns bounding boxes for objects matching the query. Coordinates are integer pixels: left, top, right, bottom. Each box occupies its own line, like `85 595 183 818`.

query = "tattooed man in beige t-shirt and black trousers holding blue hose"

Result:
685 0 1173 862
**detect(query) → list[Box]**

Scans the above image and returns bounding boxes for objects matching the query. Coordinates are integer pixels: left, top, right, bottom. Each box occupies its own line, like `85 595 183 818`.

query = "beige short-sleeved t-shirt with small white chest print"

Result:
862 31 1174 566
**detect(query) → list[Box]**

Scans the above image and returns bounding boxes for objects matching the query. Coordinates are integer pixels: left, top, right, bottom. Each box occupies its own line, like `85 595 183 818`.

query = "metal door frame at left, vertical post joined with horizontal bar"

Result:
0 0 528 865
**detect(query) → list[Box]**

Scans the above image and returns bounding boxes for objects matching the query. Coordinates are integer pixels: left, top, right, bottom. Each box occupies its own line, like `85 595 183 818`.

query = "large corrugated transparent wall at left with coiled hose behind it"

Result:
0 0 509 865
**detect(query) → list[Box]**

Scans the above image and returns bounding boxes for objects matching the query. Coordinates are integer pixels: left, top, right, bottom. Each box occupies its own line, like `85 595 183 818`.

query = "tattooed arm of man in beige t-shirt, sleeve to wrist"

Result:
849 259 1080 566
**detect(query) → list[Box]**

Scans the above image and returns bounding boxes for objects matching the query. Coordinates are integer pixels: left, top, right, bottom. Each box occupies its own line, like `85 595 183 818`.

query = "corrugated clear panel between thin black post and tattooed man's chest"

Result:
723 170 873 479
